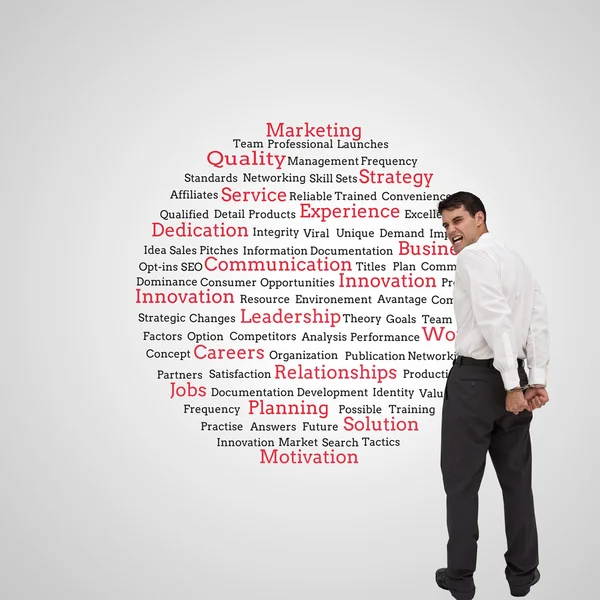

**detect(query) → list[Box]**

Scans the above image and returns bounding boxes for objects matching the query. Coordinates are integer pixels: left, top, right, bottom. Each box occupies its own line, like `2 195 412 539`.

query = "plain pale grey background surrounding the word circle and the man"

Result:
0 1 600 600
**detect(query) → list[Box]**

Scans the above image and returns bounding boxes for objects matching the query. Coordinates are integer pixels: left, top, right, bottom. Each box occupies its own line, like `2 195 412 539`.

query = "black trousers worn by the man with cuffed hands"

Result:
441 365 538 592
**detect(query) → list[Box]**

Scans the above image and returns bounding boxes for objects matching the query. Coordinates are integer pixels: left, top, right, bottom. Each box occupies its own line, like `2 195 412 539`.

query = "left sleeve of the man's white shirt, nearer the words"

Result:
456 251 520 390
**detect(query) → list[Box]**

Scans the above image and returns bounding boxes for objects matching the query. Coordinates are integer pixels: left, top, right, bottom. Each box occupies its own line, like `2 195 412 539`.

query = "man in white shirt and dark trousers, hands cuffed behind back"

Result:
436 192 548 600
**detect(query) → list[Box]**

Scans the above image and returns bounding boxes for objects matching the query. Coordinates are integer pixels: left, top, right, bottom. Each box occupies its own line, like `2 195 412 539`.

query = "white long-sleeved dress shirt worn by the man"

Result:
454 233 549 390
